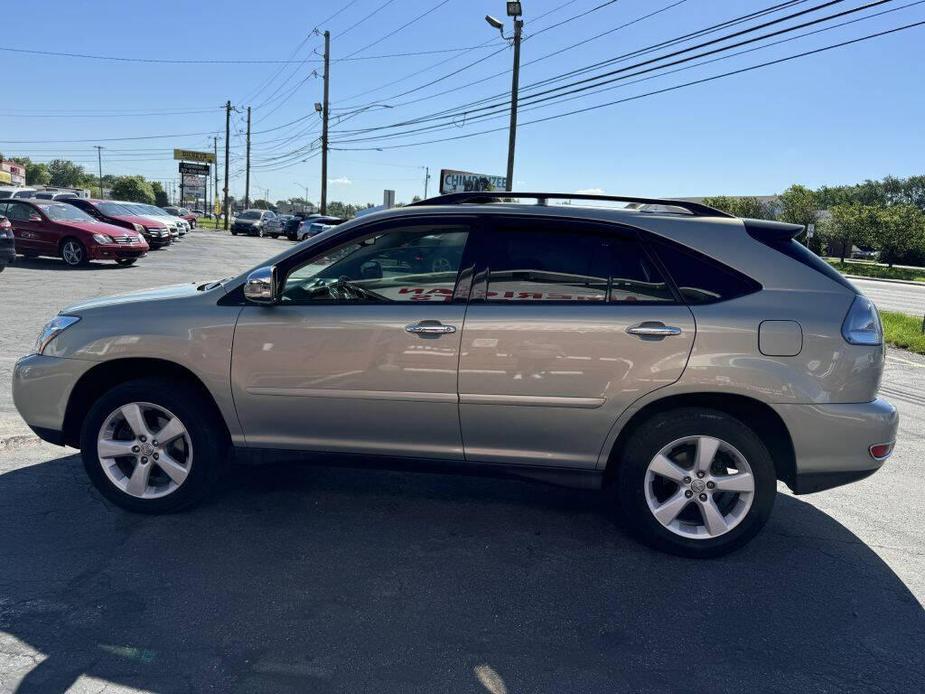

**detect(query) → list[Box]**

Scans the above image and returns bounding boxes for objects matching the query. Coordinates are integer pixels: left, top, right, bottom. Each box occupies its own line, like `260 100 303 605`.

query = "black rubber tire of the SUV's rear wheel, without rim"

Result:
615 408 777 558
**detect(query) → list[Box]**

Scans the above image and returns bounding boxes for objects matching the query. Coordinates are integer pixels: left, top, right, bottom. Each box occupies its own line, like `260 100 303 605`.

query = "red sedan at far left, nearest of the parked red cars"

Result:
0 199 148 267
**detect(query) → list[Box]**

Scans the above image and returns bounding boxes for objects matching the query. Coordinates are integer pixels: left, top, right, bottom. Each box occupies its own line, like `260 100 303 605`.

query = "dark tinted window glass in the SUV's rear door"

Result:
484 220 675 303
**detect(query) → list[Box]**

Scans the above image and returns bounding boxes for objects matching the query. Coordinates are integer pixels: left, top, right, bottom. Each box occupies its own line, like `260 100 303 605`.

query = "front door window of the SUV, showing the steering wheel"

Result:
281 224 468 304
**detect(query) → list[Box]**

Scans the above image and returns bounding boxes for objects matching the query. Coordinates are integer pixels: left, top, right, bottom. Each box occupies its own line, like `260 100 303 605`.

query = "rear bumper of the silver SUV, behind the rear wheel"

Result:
772 399 899 494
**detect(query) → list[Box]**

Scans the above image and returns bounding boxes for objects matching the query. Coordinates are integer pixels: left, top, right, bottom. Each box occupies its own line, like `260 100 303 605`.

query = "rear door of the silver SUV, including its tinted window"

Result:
459 216 694 468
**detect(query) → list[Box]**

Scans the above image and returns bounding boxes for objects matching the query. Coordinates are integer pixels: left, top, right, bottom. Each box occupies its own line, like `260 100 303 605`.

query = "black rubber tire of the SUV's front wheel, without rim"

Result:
80 379 229 514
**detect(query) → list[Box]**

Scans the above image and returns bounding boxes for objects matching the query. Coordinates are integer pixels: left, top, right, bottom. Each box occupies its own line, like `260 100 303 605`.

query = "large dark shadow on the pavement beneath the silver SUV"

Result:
0 456 925 692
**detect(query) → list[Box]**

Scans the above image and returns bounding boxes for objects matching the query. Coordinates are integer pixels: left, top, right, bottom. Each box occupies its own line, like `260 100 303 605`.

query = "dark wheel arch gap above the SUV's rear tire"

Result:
604 393 796 489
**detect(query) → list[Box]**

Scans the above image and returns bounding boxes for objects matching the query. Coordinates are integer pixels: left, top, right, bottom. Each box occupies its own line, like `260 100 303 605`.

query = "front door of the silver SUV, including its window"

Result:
231 217 471 460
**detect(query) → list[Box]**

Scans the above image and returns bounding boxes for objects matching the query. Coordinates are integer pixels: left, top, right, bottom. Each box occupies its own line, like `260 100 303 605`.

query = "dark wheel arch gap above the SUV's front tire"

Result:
62 357 231 448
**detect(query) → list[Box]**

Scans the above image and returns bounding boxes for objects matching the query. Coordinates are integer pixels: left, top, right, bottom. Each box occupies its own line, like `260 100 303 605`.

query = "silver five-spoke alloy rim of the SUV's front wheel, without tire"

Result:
96 402 193 499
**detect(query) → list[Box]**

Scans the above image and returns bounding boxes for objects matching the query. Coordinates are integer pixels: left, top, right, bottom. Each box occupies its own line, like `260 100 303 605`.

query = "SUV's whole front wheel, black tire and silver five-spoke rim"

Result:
80 379 227 513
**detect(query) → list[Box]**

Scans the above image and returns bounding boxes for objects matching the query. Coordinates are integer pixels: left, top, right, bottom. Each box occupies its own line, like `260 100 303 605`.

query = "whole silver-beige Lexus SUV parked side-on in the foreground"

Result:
13 193 897 557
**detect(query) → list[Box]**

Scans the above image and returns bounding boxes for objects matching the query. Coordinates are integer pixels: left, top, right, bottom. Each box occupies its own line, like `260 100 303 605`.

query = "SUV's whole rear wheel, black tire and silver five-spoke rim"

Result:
617 408 777 558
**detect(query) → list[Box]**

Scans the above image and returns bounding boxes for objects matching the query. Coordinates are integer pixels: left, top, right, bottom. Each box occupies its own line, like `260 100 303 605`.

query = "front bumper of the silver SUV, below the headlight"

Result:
13 354 97 445
